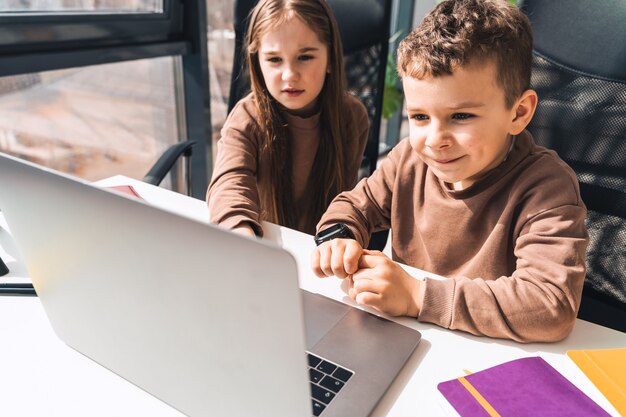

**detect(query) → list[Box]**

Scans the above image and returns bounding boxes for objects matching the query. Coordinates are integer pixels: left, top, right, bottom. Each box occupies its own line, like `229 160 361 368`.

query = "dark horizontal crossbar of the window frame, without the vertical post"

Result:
0 0 185 76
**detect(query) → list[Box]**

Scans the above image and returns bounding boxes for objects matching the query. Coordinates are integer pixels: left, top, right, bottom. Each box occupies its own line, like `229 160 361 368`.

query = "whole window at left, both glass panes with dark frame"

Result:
0 0 210 198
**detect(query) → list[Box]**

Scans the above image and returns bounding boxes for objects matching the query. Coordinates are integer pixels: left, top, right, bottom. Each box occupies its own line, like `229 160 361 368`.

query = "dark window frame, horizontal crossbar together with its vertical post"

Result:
0 0 211 198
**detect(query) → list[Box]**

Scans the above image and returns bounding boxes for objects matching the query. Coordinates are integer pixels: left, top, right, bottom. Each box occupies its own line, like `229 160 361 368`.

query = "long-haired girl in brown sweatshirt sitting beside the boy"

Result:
207 0 369 236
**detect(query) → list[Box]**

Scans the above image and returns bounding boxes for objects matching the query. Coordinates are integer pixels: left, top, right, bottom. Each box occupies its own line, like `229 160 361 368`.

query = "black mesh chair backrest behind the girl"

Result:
228 0 391 175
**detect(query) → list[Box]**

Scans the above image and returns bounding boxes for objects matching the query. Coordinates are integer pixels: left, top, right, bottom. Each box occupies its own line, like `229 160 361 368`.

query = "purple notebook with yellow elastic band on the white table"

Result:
437 357 610 417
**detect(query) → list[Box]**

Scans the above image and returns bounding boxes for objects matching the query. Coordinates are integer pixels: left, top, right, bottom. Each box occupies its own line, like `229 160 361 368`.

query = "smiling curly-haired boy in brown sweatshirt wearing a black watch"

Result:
312 0 587 342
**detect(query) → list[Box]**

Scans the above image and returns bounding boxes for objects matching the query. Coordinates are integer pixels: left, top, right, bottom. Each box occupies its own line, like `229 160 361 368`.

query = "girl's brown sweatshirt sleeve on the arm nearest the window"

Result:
206 96 263 236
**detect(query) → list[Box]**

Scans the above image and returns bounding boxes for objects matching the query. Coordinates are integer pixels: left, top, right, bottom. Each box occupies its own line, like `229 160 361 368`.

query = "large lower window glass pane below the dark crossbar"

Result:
0 57 179 180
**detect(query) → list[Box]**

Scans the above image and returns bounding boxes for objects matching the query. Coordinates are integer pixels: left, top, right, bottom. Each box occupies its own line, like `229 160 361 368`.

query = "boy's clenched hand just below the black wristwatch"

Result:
311 239 363 278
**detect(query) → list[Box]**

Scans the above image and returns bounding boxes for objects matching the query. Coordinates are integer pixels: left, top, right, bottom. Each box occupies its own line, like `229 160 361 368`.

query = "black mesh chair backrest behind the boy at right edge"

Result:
520 0 626 331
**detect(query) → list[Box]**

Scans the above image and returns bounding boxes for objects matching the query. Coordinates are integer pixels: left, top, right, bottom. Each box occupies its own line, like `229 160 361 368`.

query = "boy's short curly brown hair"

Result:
397 0 533 108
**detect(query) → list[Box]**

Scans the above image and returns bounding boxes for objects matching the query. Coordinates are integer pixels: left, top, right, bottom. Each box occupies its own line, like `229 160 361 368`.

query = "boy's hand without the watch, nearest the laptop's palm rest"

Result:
348 250 421 317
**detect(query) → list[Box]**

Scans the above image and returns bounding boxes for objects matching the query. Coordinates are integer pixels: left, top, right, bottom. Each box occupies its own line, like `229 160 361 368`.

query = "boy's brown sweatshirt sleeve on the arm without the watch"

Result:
418 184 587 342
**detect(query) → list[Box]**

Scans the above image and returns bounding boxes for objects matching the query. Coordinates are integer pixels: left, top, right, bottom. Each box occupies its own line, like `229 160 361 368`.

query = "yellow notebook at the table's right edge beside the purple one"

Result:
567 348 626 416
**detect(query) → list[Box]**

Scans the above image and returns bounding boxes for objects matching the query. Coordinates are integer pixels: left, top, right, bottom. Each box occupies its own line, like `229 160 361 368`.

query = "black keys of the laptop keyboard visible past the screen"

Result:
307 352 354 416
